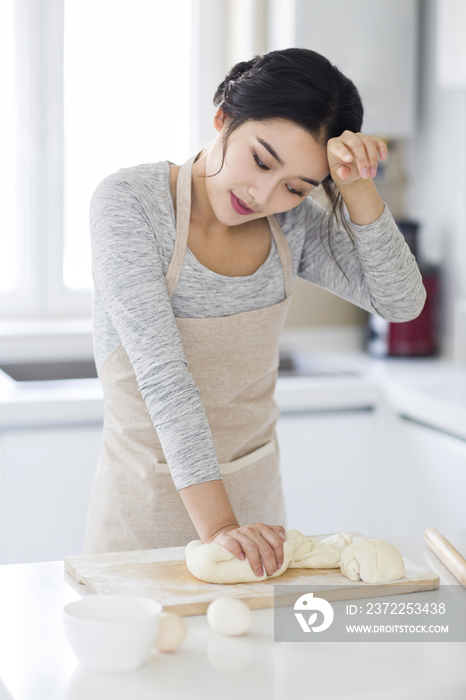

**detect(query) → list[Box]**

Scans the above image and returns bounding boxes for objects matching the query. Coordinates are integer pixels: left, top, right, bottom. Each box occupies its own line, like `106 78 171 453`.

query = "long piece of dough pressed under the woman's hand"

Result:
186 530 353 583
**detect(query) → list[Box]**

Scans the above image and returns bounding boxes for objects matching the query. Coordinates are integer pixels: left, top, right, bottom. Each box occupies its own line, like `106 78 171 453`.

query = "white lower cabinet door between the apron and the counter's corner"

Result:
277 410 377 536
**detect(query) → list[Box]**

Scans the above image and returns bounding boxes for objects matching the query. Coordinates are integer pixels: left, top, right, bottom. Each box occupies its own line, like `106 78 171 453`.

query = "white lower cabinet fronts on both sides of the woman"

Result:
0 382 466 564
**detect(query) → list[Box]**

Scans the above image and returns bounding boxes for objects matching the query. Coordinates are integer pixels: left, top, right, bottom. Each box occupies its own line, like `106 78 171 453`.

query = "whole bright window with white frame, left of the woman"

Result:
0 0 192 319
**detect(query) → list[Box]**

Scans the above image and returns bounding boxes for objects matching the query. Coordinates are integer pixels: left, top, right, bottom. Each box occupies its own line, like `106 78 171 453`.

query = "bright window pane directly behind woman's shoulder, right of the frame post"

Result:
64 0 191 289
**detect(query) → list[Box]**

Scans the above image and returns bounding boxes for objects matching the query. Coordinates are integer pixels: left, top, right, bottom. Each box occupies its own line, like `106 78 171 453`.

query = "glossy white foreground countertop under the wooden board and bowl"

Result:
0 530 466 700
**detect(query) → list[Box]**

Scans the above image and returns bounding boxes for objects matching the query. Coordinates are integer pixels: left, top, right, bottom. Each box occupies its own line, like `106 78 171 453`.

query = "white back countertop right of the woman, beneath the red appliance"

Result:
275 329 466 440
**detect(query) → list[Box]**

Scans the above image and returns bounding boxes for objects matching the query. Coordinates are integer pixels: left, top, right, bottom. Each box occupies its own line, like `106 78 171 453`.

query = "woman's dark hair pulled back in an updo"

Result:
214 48 363 262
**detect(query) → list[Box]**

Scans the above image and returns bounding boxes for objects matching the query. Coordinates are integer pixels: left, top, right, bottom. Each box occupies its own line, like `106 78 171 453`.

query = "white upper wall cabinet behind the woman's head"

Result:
269 0 419 138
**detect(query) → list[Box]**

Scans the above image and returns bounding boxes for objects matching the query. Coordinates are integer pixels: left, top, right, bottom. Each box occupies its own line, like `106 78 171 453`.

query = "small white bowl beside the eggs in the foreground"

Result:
63 595 162 671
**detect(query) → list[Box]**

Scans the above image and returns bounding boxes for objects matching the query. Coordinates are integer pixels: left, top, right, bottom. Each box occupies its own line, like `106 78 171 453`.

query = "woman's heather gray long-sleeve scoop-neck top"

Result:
90 161 425 490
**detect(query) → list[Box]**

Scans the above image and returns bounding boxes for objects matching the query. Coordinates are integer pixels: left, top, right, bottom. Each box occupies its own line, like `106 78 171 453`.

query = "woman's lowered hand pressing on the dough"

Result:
209 523 286 576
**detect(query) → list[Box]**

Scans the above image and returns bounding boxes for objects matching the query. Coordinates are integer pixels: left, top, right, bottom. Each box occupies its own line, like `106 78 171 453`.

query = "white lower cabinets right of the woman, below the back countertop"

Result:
277 404 466 538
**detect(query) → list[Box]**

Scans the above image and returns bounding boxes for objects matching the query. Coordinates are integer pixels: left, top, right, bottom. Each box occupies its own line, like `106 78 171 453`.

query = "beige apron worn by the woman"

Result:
80 157 292 553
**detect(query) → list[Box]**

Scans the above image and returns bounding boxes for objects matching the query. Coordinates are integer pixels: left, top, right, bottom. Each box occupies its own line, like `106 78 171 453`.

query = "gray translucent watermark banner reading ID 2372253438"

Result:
274 583 466 643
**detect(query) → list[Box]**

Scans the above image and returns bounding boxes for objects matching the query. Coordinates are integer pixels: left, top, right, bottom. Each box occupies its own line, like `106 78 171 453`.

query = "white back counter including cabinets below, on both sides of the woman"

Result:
0 329 466 564
